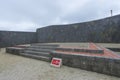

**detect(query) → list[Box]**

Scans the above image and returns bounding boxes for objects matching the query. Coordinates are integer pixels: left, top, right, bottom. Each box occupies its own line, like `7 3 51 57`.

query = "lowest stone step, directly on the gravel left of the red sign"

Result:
20 53 50 62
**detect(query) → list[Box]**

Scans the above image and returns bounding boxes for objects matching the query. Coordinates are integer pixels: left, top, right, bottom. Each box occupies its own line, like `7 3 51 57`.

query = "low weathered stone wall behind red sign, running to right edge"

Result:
51 52 120 77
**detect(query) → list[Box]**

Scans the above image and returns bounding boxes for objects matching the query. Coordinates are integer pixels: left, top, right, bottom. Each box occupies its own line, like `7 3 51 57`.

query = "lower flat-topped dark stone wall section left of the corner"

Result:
0 31 36 47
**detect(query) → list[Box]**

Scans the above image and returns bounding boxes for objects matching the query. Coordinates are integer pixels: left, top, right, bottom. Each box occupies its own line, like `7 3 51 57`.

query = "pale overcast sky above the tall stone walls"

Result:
0 0 120 31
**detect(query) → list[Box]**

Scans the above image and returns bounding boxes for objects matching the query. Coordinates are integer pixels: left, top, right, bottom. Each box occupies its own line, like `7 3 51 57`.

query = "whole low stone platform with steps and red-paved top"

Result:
6 43 120 77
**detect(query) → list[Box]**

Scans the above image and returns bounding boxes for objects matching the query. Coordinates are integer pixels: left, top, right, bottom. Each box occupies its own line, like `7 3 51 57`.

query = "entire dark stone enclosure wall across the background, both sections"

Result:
0 15 120 47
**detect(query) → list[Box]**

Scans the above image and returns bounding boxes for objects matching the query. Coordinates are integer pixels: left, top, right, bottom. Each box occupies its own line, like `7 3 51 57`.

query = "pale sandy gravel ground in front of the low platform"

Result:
0 49 120 80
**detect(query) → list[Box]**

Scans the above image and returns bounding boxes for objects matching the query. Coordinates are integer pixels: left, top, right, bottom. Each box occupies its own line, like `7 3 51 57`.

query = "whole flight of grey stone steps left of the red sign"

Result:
20 44 59 62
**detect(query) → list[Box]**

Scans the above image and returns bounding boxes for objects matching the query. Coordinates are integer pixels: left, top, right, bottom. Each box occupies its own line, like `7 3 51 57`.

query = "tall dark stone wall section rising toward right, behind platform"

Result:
37 15 120 43
